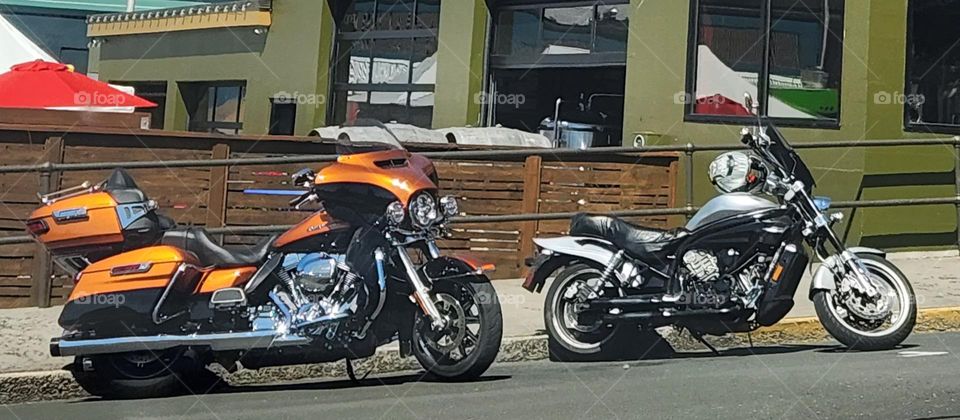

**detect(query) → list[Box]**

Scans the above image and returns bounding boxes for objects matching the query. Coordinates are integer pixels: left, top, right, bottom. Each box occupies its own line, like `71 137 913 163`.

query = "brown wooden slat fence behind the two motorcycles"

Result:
0 126 678 308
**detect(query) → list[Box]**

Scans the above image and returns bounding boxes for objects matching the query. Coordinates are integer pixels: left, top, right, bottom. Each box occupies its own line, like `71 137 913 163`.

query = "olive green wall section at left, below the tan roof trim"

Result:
91 0 333 135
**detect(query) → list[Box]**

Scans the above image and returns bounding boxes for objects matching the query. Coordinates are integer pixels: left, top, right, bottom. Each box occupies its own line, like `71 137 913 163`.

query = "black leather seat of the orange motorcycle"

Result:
160 227 277 267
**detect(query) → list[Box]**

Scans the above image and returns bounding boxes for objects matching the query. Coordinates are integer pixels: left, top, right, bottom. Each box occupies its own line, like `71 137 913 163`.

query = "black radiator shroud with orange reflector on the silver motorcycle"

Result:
757 244 810 327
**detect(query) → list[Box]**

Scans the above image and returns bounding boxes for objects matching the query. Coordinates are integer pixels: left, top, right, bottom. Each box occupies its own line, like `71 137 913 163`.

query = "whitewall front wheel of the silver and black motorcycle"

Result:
813 254 917 350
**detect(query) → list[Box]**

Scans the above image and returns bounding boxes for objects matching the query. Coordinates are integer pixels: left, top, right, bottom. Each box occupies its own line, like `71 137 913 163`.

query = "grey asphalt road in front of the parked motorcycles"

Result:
9 334 960 420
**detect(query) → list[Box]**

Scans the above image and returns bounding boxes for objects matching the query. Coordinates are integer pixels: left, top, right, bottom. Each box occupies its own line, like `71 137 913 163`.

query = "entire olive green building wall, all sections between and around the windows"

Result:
91 0 957 248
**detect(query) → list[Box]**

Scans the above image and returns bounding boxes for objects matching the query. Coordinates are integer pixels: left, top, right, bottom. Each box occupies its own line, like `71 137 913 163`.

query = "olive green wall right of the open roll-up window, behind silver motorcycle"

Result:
624 0 957 248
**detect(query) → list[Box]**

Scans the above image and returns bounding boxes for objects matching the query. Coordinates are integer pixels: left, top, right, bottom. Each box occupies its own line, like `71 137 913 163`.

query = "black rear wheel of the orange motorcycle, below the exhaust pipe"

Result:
71 348 220 399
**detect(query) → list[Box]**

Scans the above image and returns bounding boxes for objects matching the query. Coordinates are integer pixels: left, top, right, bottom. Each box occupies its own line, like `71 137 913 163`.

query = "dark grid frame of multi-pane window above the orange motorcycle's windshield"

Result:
326 0 443 123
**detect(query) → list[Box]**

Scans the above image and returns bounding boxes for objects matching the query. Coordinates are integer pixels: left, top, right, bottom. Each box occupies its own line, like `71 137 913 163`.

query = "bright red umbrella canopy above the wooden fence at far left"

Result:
0 60 157 108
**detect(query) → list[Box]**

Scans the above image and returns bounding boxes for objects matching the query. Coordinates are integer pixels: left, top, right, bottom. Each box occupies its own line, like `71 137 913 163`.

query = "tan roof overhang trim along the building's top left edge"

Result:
87 0 271 38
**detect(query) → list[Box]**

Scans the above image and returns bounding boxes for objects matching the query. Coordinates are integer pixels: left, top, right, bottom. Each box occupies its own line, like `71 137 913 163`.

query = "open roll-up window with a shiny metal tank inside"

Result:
488 0 635 148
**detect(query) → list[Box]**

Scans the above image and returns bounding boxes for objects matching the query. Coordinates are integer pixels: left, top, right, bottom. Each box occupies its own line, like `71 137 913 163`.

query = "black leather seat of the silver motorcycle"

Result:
570 213 688 260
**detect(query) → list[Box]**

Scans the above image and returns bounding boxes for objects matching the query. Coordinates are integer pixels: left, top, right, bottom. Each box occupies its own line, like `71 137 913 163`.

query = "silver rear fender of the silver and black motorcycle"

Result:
523 236 636 292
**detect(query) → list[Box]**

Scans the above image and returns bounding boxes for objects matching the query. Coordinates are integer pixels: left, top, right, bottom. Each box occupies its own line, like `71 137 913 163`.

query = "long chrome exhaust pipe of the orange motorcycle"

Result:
50 330 311 356
